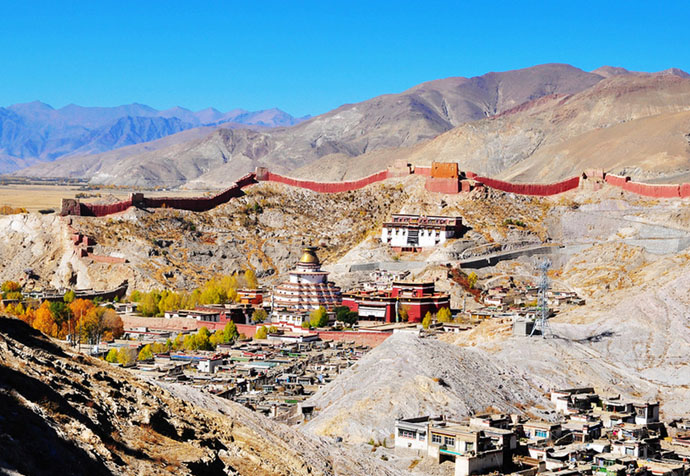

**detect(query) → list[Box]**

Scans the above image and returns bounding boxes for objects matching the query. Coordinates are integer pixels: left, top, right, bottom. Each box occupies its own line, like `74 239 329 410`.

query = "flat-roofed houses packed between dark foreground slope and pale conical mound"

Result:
130 339 369 418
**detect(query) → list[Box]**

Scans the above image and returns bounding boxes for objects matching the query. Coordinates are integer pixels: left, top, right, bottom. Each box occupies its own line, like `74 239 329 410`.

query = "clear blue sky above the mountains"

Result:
0 0 690 115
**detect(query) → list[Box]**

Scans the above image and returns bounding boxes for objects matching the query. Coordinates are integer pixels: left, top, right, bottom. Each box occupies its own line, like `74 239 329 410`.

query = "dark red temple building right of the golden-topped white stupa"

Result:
343 282 450 322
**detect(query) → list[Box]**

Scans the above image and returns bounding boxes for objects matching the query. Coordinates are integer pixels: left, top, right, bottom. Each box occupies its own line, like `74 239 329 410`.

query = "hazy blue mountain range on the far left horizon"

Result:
0 101 304 173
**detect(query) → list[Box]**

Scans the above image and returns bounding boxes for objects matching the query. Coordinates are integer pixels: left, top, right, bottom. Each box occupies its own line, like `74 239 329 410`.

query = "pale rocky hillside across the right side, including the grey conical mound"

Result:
298 189 690 441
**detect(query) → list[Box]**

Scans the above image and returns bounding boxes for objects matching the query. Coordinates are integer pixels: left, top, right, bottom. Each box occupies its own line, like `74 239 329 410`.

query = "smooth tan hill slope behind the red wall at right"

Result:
390 74 690 181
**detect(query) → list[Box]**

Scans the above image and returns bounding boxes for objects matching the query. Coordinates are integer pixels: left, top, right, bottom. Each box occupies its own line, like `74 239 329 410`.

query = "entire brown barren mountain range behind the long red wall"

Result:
18 64 690 188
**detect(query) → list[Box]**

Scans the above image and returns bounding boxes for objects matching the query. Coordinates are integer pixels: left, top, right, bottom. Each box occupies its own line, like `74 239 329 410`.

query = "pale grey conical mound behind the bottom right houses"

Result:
305 331 548 443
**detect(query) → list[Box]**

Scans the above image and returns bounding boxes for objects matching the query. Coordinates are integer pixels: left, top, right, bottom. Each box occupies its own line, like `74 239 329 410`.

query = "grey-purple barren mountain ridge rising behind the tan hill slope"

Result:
21 64 602 187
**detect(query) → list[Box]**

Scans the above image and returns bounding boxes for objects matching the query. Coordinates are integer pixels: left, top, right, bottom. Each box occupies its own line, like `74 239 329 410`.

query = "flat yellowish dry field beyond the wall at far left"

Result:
0 184 210 212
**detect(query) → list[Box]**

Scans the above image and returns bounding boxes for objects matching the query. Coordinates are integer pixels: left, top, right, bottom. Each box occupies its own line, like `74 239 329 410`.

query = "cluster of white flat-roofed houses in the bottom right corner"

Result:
395 387 690 476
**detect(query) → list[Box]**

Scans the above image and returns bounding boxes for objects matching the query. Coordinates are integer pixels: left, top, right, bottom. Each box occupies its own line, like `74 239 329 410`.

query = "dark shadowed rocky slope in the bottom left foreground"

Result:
0 317 404 475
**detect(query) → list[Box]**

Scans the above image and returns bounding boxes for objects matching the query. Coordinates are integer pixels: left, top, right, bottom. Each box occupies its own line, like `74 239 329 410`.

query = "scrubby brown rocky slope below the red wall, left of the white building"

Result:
0 178 407 289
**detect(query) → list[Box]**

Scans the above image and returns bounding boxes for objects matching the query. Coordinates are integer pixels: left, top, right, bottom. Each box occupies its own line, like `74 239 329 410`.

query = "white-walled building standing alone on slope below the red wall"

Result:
381 214 462 249
